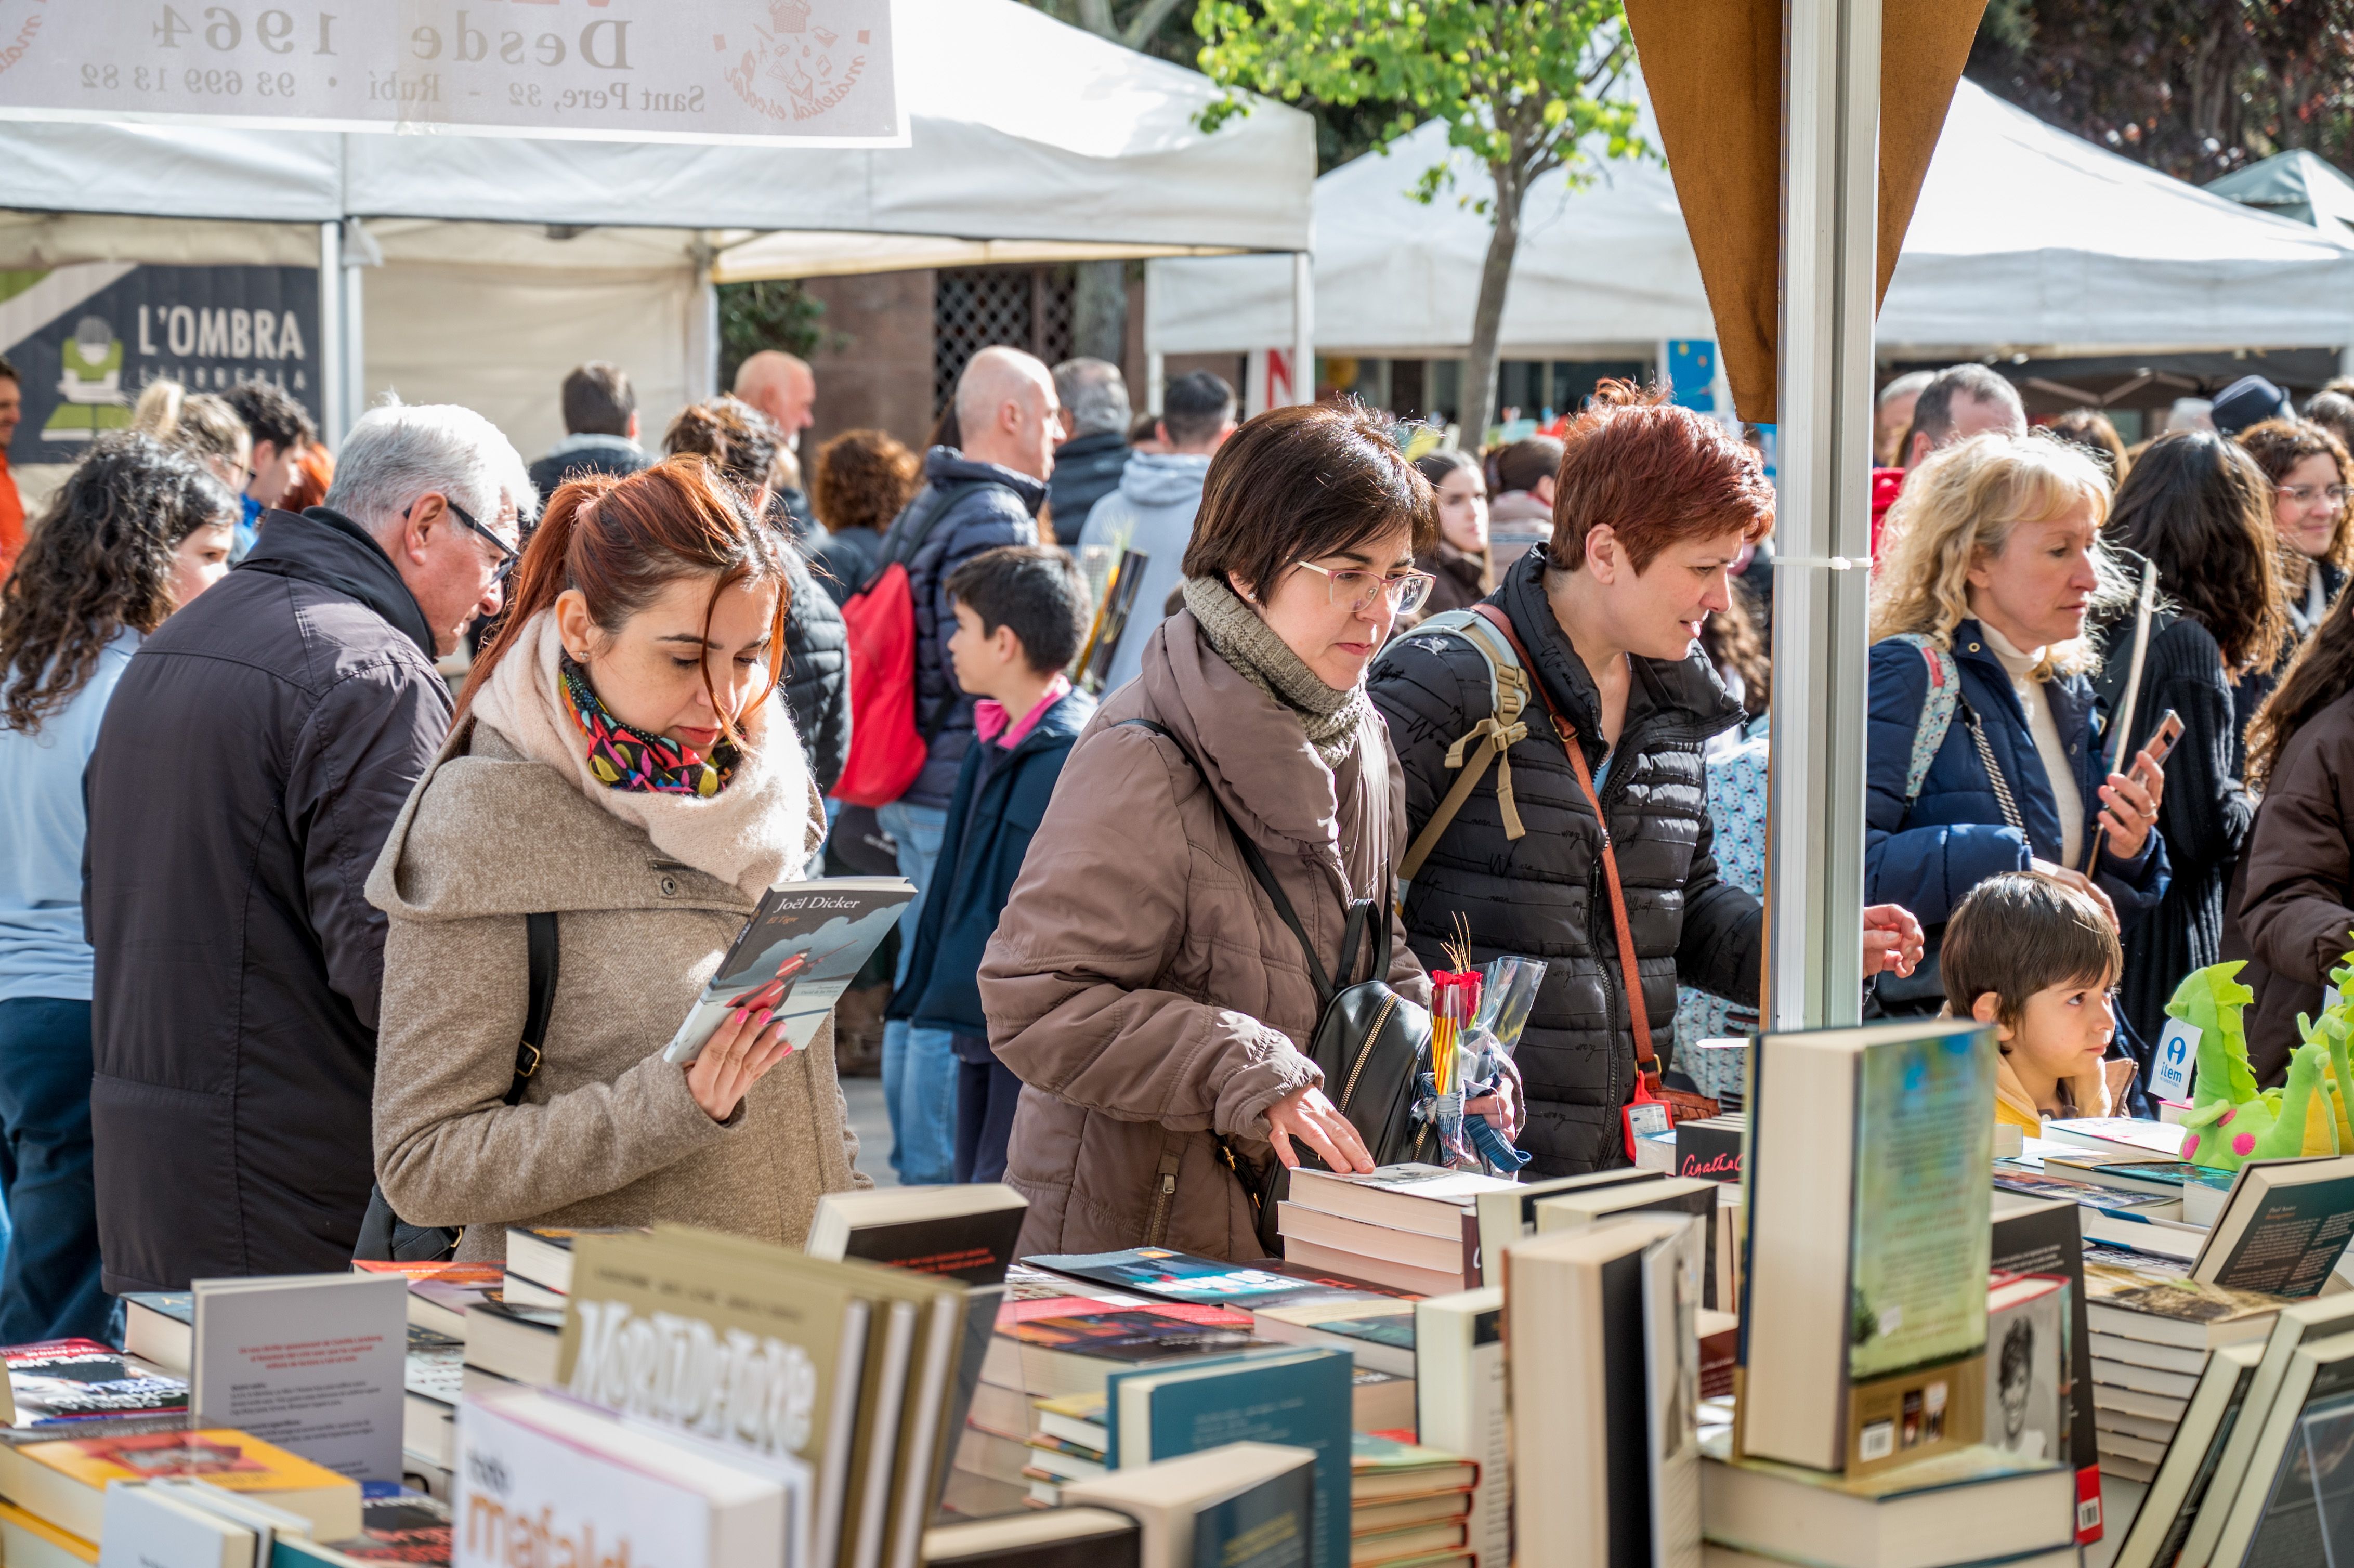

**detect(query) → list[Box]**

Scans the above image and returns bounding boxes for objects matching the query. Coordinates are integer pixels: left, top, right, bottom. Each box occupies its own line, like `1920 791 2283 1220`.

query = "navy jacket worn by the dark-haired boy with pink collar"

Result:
887 692 1095 1041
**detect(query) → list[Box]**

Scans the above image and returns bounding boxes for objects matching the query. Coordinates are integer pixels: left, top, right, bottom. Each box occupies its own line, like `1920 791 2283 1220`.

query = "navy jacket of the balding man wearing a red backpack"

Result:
883 447 1045 807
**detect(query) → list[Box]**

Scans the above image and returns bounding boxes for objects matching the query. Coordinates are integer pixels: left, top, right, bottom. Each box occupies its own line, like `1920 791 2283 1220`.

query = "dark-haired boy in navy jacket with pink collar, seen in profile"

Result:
887 544 1095 1182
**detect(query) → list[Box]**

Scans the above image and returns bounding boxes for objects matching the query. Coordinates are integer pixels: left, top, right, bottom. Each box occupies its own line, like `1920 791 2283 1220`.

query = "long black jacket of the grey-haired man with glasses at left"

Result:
82 506 452 1292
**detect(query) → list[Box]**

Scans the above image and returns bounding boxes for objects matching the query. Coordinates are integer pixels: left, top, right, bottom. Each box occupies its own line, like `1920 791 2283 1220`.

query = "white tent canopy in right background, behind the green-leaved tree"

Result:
1146 82 2354 358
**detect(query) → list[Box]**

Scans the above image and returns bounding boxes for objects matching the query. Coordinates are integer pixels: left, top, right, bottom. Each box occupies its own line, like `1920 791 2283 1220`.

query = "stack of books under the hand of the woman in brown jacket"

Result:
1278 1166 1514 1295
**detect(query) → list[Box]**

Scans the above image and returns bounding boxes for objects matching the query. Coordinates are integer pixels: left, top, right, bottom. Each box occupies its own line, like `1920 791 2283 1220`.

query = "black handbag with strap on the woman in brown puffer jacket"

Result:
1123 718 1431 1255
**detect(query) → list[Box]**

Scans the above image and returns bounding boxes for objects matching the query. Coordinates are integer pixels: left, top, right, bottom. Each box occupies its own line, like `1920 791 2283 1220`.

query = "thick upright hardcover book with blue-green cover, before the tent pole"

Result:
1733 1022 1996 1474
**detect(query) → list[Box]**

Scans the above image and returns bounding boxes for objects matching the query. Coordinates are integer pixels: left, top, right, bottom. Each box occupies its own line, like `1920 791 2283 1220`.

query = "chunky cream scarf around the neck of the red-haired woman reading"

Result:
473 610 810 897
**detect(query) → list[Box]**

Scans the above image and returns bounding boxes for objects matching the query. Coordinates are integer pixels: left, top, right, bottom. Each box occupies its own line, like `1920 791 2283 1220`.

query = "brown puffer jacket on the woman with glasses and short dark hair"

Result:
982 610 1429 1257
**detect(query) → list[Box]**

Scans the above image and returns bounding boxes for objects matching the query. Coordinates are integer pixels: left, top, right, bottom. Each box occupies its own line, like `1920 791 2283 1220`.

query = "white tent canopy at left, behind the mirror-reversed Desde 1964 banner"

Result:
0 0 1316 452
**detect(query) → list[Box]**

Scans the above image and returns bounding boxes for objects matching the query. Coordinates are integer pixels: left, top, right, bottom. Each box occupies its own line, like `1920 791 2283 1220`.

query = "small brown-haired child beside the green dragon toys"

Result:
1942 871 2133 1135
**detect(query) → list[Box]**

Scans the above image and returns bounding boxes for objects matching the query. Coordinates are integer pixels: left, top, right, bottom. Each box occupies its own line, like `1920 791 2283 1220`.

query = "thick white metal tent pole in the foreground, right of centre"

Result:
1766 0 1881 1029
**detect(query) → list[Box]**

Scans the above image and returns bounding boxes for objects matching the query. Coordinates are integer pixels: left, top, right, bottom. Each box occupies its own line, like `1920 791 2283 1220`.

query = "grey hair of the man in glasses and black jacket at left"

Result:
325 400 539 534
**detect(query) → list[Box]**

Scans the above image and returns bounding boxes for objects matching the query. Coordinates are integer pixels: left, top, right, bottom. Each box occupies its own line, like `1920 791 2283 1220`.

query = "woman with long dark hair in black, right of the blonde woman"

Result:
2100 431 2288 1048
